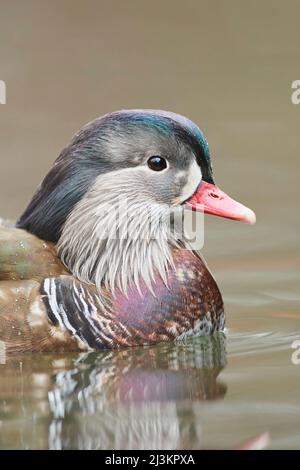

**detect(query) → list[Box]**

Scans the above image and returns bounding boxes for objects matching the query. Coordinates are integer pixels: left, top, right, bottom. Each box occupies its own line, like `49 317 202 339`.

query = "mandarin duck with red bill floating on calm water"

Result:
0 110 255 352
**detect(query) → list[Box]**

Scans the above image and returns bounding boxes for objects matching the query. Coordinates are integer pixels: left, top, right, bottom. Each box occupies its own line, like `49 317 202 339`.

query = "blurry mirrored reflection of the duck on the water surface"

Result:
0 334 226 449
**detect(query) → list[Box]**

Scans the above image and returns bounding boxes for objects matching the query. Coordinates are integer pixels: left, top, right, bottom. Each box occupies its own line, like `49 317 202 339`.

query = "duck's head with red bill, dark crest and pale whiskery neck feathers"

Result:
17 110 255 291
